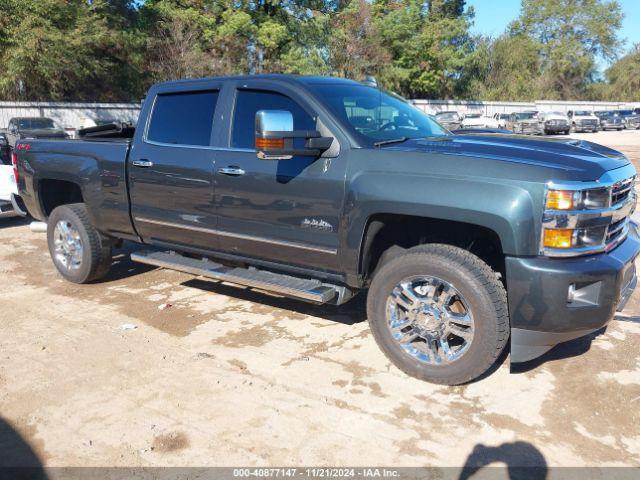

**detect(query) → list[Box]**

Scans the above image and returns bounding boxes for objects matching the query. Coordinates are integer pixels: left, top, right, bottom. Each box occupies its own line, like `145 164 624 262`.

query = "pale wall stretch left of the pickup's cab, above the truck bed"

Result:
0 102 140 133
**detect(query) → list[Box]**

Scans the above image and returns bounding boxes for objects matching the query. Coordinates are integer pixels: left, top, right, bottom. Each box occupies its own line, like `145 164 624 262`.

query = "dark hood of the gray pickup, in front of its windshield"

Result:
383 134 629 180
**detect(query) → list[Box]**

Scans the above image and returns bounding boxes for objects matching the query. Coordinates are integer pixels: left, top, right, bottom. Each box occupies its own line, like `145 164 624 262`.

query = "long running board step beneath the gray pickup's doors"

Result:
131 251 343 303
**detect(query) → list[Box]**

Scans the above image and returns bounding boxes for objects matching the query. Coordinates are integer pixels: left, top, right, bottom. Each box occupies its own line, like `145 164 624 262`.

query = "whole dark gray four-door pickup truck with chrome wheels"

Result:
16 75 640 384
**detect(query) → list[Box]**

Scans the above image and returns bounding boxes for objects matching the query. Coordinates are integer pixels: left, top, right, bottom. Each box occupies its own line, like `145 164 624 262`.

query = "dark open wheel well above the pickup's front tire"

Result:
360 214 505 281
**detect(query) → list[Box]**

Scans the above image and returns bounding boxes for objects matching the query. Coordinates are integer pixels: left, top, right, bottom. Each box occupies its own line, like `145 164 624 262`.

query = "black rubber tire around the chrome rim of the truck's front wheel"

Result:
367 244 509 385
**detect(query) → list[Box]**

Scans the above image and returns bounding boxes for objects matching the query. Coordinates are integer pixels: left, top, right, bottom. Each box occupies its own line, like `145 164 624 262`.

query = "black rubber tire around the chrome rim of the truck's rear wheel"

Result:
47 203 113 283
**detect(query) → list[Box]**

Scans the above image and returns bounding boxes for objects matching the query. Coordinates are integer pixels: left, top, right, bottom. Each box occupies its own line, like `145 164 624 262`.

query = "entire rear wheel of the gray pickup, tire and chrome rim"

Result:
47 203 112 283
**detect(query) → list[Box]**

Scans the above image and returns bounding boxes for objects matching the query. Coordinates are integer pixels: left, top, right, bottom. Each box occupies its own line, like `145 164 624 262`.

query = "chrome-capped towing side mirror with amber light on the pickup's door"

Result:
256 110 333 160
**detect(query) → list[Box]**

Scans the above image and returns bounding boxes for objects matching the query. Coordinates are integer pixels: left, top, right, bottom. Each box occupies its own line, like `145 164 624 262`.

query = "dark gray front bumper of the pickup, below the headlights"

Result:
506 223 640 363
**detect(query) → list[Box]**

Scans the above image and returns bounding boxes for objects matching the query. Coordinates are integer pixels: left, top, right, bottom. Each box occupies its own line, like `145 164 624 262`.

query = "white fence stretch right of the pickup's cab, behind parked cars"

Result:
412 100 640 116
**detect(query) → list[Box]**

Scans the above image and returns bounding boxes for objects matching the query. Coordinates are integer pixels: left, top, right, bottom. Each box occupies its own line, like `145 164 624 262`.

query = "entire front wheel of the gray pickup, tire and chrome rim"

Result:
367 244 509 385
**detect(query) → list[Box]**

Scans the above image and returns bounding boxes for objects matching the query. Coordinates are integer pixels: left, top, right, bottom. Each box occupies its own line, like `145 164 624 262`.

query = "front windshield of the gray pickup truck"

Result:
312 83 449 143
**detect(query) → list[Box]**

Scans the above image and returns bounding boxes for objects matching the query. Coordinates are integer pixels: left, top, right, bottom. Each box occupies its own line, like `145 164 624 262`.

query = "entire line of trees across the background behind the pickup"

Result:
0 0 640 101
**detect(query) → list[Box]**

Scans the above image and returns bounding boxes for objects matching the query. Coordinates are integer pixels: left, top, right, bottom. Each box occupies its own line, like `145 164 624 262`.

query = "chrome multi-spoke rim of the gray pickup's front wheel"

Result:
386 276 474 365
